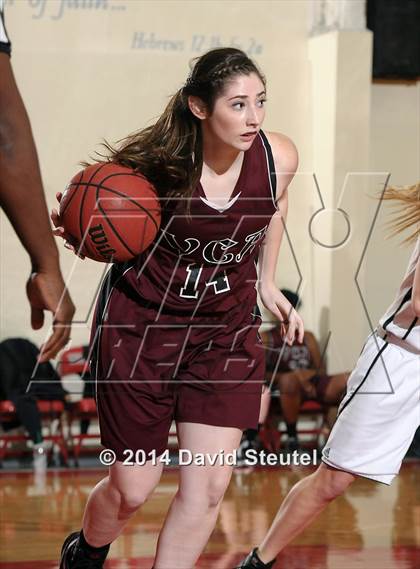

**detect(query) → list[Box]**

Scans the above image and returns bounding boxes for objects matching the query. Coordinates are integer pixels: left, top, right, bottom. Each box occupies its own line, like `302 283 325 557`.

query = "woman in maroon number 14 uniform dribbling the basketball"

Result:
53 48 303 569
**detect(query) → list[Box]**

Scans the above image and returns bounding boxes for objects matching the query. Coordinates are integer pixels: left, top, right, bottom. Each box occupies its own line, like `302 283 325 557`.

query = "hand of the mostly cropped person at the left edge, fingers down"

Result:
26 269 75 362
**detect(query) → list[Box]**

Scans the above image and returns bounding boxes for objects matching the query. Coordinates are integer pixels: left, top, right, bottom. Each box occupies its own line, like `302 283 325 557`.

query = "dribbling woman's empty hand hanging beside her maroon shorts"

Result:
259 285 305 346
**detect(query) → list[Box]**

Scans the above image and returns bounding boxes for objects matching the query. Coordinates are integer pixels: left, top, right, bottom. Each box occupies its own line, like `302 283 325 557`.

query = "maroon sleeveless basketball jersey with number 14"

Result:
125 131 276 316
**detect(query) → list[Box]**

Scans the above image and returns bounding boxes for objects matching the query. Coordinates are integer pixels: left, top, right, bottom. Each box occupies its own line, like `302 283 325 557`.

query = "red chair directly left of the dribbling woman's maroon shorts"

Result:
58 346 100 465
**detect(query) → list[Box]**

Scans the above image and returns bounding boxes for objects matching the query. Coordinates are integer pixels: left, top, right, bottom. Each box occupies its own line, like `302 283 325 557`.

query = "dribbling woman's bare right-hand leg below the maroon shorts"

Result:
154 423 242 569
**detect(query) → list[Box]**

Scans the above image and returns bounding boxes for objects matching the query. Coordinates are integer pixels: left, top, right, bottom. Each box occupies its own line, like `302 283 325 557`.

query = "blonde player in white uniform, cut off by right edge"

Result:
238 183 420 569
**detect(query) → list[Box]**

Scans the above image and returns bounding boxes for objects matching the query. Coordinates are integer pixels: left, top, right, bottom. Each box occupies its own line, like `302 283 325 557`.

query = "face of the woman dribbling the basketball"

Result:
203 73 266 150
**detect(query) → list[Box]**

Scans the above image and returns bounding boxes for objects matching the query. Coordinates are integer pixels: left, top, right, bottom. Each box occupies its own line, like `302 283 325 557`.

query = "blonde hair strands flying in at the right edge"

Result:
382 182 420 243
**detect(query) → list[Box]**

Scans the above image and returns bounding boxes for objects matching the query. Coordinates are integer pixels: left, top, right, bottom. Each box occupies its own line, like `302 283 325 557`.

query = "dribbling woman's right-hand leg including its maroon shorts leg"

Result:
155 306 264 569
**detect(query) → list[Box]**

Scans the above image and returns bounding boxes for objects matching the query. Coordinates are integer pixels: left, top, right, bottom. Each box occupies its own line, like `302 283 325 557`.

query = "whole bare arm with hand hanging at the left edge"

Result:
0 53 74 361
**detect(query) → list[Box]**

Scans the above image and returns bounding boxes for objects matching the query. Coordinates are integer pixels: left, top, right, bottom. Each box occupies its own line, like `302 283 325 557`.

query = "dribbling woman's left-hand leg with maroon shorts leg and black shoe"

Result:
60 271 174 569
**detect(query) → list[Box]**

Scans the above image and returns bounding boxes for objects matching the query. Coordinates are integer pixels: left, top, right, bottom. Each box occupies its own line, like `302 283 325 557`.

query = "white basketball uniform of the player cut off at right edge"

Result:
322 238 420 484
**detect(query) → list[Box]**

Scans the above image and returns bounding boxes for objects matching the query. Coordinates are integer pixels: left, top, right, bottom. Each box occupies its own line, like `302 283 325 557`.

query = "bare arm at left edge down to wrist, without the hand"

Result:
0 59 58 270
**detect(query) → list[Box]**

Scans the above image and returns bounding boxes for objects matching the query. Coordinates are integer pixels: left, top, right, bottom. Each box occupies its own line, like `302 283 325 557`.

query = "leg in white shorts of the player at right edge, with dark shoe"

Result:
240 330 420 569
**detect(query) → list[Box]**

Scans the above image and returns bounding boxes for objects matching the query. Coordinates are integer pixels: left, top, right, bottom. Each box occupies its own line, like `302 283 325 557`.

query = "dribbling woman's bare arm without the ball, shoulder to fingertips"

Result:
258 133 304 345
